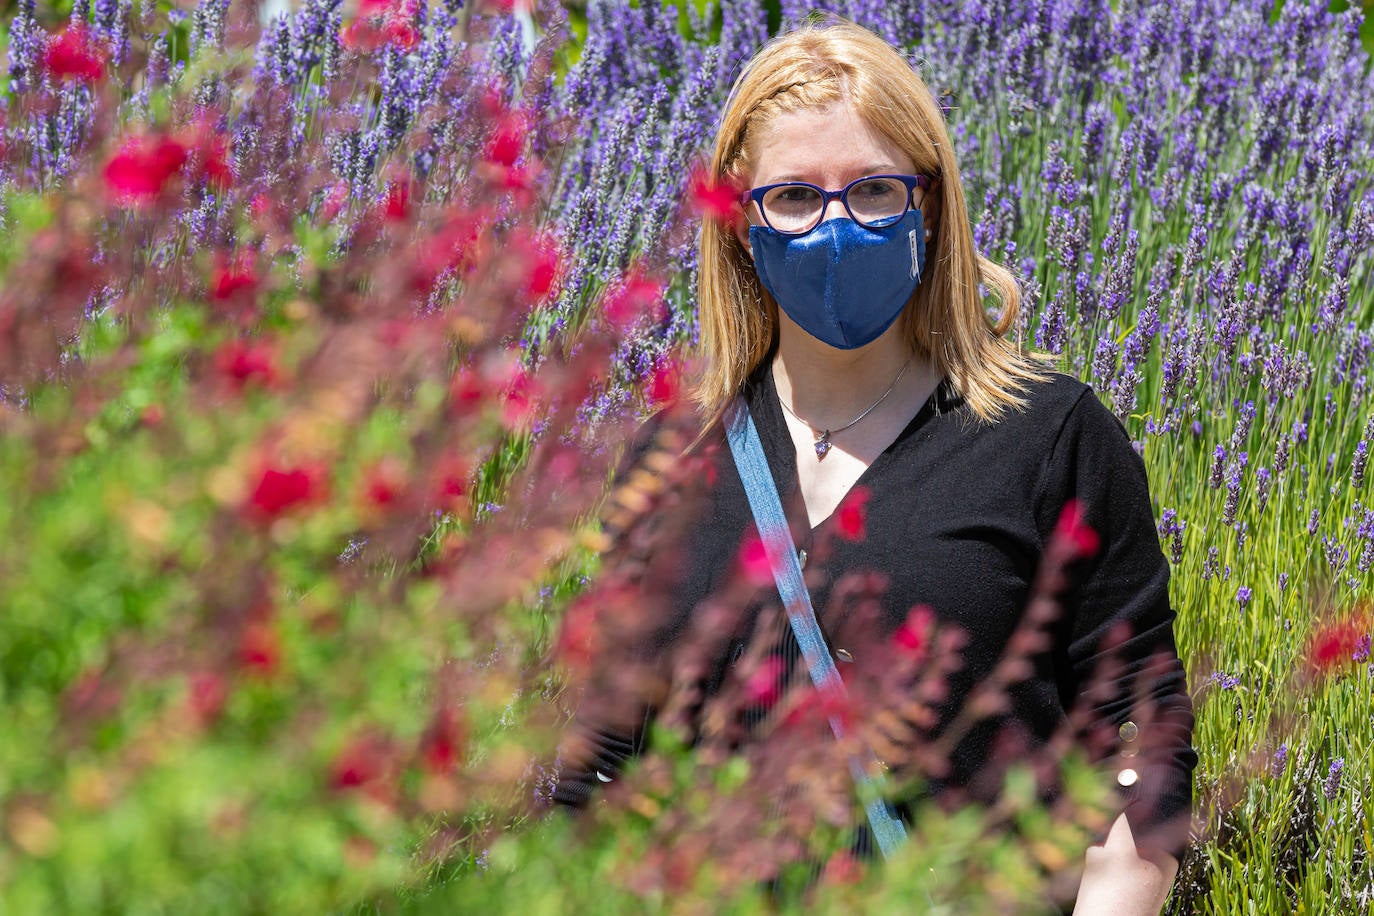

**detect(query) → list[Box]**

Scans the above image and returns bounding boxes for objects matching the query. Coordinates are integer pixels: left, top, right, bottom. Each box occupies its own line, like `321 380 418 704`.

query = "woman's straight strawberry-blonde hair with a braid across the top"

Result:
694 19 1046 420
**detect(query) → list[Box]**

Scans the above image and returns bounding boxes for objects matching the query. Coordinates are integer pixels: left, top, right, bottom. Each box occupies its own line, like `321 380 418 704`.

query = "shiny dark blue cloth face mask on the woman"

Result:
749 209 926 350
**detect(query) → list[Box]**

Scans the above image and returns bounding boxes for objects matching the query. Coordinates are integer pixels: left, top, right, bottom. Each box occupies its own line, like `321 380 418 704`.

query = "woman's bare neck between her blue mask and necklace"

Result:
772 317 923 428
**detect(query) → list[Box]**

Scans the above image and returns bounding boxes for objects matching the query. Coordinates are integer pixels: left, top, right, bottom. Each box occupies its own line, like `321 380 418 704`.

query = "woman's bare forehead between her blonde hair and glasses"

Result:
750 99 915 187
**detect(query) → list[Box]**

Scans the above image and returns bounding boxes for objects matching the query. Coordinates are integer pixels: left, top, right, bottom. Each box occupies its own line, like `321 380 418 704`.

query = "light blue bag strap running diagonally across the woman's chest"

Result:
723 398 907 858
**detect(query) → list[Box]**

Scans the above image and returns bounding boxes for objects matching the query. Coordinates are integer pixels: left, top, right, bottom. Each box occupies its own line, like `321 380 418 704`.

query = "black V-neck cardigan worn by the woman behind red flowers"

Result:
555 363 1197 857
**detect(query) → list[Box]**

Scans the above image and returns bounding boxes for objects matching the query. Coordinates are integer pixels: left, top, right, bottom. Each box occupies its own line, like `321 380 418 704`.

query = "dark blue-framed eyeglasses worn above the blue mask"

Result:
739 174 930 235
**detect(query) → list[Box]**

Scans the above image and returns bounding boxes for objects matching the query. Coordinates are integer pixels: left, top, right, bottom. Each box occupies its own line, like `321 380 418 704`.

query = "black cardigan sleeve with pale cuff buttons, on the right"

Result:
1037 389 1197 861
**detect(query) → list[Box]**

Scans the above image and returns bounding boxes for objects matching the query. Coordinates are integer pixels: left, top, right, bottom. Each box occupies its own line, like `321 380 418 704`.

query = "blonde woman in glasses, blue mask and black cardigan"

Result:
559 17 1195 915
